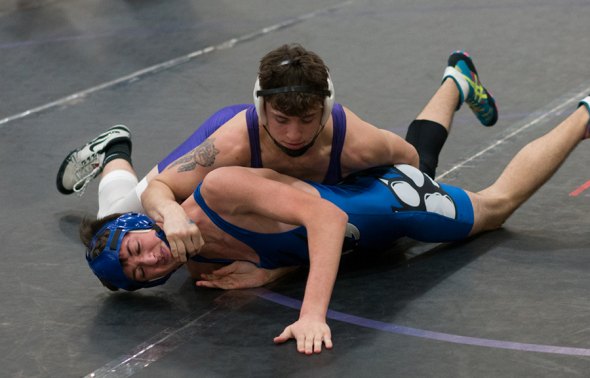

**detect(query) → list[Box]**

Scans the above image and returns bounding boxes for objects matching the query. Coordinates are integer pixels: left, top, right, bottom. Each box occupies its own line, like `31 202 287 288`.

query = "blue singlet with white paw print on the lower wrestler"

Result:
194 165 473 269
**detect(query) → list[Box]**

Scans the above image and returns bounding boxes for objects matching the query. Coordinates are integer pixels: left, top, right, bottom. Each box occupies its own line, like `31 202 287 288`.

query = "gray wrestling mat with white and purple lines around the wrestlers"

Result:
0 0 590 377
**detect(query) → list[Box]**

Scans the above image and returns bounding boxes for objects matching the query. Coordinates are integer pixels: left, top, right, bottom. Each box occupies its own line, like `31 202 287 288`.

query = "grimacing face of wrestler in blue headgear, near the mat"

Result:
119 230 182 282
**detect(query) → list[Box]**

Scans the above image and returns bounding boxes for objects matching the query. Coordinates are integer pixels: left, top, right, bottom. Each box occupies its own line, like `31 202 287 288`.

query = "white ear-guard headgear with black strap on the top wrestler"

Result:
253 72 334 126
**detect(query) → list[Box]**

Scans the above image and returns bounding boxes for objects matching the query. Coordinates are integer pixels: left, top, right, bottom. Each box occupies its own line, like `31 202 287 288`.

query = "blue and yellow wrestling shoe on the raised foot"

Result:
443 50 498 126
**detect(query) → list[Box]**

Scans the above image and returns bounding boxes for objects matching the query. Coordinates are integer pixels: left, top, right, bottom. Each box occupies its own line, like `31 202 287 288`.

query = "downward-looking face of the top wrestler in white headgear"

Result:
266 103 322 156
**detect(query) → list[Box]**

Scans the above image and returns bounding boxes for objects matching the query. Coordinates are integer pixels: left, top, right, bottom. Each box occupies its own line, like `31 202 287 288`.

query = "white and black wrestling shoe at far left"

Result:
56 125 131 195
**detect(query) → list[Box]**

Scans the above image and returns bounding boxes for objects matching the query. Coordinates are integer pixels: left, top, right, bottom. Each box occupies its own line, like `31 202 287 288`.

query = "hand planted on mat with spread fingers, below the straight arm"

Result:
274 317 332 355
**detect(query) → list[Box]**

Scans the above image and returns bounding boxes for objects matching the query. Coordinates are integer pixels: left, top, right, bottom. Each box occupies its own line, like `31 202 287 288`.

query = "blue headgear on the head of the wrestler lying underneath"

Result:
86 213 174 291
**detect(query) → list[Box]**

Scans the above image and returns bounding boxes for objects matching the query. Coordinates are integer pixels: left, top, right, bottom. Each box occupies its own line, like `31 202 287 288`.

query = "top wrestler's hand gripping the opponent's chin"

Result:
162 209 203 263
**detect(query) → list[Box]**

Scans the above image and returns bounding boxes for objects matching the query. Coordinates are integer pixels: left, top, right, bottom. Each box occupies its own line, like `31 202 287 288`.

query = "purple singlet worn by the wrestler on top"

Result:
158 104 346 184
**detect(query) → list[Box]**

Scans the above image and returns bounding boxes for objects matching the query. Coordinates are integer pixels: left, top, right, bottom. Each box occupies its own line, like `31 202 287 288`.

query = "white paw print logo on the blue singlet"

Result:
379 164 457 219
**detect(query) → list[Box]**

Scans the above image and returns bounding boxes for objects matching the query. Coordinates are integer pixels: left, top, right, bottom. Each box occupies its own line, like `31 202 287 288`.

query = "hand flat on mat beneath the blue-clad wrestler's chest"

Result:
196 261 297 290
